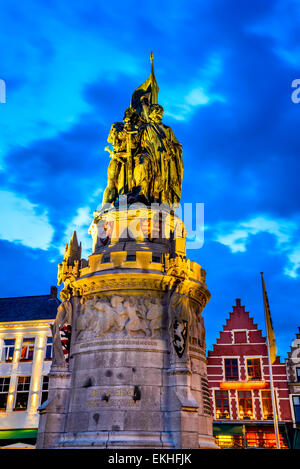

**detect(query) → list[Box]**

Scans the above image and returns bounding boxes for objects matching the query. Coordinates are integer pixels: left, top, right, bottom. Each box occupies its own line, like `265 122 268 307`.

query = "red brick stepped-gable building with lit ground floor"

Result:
207 299 292 448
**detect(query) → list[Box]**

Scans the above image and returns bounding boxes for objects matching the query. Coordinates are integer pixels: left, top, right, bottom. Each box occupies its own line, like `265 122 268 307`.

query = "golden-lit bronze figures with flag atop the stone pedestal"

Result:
103 52 183 206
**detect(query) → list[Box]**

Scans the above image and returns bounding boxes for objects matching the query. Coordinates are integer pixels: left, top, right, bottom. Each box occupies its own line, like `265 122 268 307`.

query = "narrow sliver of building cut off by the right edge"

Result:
286 328 300 449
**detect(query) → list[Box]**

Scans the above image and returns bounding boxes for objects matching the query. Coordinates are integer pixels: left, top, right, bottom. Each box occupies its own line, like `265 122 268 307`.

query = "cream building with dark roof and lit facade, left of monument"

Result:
0 287 60 446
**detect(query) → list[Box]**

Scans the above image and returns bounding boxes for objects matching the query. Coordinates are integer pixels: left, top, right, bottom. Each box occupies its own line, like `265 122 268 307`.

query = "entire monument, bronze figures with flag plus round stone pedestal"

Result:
36 55 216 451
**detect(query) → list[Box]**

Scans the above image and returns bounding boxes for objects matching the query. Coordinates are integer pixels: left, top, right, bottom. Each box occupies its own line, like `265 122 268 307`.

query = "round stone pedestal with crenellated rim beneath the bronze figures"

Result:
37 209 216 448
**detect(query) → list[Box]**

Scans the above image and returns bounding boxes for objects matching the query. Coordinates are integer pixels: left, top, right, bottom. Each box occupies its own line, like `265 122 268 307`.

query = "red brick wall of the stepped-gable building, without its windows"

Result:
207 300 291 448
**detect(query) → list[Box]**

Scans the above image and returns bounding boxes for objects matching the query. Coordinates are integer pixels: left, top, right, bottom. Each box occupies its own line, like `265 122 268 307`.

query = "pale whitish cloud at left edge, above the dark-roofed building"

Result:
0 191 54 250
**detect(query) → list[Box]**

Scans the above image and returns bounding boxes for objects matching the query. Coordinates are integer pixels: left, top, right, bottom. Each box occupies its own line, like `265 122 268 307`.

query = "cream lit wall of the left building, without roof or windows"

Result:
0 320 53 430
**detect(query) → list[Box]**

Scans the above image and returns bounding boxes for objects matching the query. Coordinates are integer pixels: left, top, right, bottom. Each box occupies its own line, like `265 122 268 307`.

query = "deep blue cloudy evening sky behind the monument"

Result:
0 0 300 358
